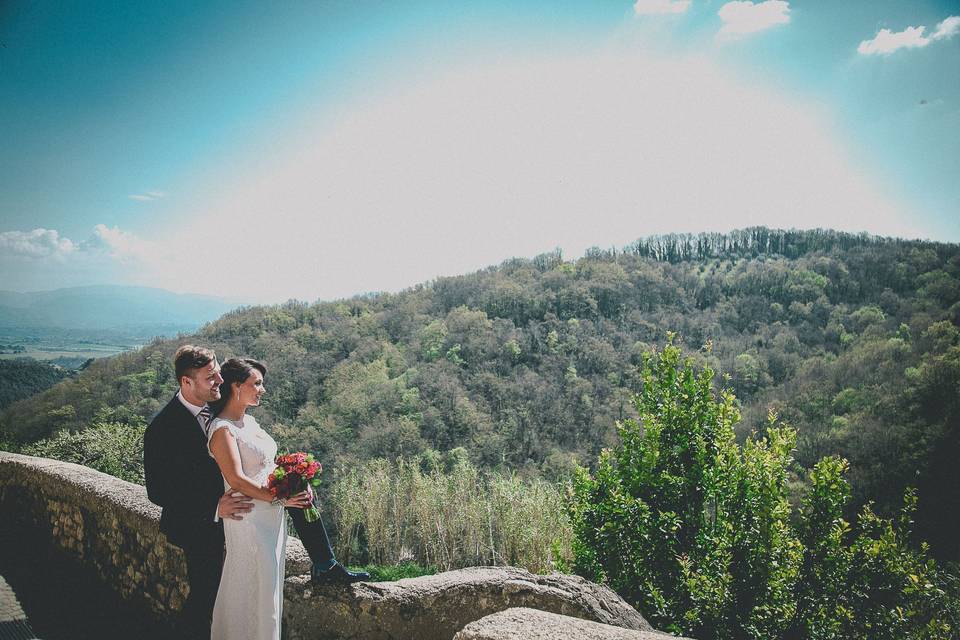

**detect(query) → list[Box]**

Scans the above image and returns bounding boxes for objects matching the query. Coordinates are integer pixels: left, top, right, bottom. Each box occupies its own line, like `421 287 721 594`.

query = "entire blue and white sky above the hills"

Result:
0 0 960 303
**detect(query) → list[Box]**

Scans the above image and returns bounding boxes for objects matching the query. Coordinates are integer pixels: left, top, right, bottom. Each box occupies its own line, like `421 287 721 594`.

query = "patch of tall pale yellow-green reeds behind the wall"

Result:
330 456 573 573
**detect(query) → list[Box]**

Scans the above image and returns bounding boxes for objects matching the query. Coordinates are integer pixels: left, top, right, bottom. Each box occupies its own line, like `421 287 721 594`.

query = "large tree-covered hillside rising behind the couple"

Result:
0 228 960 559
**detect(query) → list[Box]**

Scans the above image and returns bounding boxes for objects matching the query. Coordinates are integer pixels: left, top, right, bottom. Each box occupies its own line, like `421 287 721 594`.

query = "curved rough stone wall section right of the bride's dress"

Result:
283 567 653 640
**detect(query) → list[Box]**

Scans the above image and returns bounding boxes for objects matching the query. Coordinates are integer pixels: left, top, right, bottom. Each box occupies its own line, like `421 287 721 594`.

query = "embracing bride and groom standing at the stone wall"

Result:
143 345 369 640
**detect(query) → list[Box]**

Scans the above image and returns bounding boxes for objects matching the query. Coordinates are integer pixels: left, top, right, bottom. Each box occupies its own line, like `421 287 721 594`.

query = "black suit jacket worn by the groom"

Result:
143 396 224 553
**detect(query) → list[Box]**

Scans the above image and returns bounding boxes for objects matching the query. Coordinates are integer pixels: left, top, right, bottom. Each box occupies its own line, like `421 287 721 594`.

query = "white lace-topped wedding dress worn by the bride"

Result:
207 415 287 640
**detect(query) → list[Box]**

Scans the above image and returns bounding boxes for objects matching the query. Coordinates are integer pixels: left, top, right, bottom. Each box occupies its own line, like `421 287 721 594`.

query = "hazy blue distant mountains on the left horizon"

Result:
0 285 239 335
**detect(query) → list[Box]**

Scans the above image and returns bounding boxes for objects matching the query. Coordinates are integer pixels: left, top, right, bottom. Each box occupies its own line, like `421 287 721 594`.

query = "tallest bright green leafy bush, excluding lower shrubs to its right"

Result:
572 344 801 638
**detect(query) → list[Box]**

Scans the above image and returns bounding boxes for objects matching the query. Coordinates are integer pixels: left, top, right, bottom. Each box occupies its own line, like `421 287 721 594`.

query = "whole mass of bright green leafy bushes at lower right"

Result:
568 338 956 640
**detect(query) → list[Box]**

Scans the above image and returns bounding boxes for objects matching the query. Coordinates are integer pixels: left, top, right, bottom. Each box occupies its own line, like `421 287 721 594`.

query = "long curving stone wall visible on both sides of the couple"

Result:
0 451 684 640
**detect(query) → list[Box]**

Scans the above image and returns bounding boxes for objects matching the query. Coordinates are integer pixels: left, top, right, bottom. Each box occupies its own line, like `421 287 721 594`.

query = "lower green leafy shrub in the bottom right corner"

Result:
789 472 960 640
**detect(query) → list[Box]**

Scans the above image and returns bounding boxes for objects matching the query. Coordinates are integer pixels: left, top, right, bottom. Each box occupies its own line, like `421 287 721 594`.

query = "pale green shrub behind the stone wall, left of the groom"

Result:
21 422 146 484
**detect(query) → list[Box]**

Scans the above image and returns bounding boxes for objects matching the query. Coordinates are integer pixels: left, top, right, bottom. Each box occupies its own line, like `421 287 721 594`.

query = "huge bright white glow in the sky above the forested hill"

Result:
167 47 923 301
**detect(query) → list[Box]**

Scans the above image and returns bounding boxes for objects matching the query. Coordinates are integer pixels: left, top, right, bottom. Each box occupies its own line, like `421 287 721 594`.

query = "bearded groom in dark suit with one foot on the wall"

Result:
143 345 370 638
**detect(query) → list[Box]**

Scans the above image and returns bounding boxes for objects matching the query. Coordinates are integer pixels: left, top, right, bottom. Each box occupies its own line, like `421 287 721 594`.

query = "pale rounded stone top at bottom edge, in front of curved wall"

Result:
453 607 677 640
